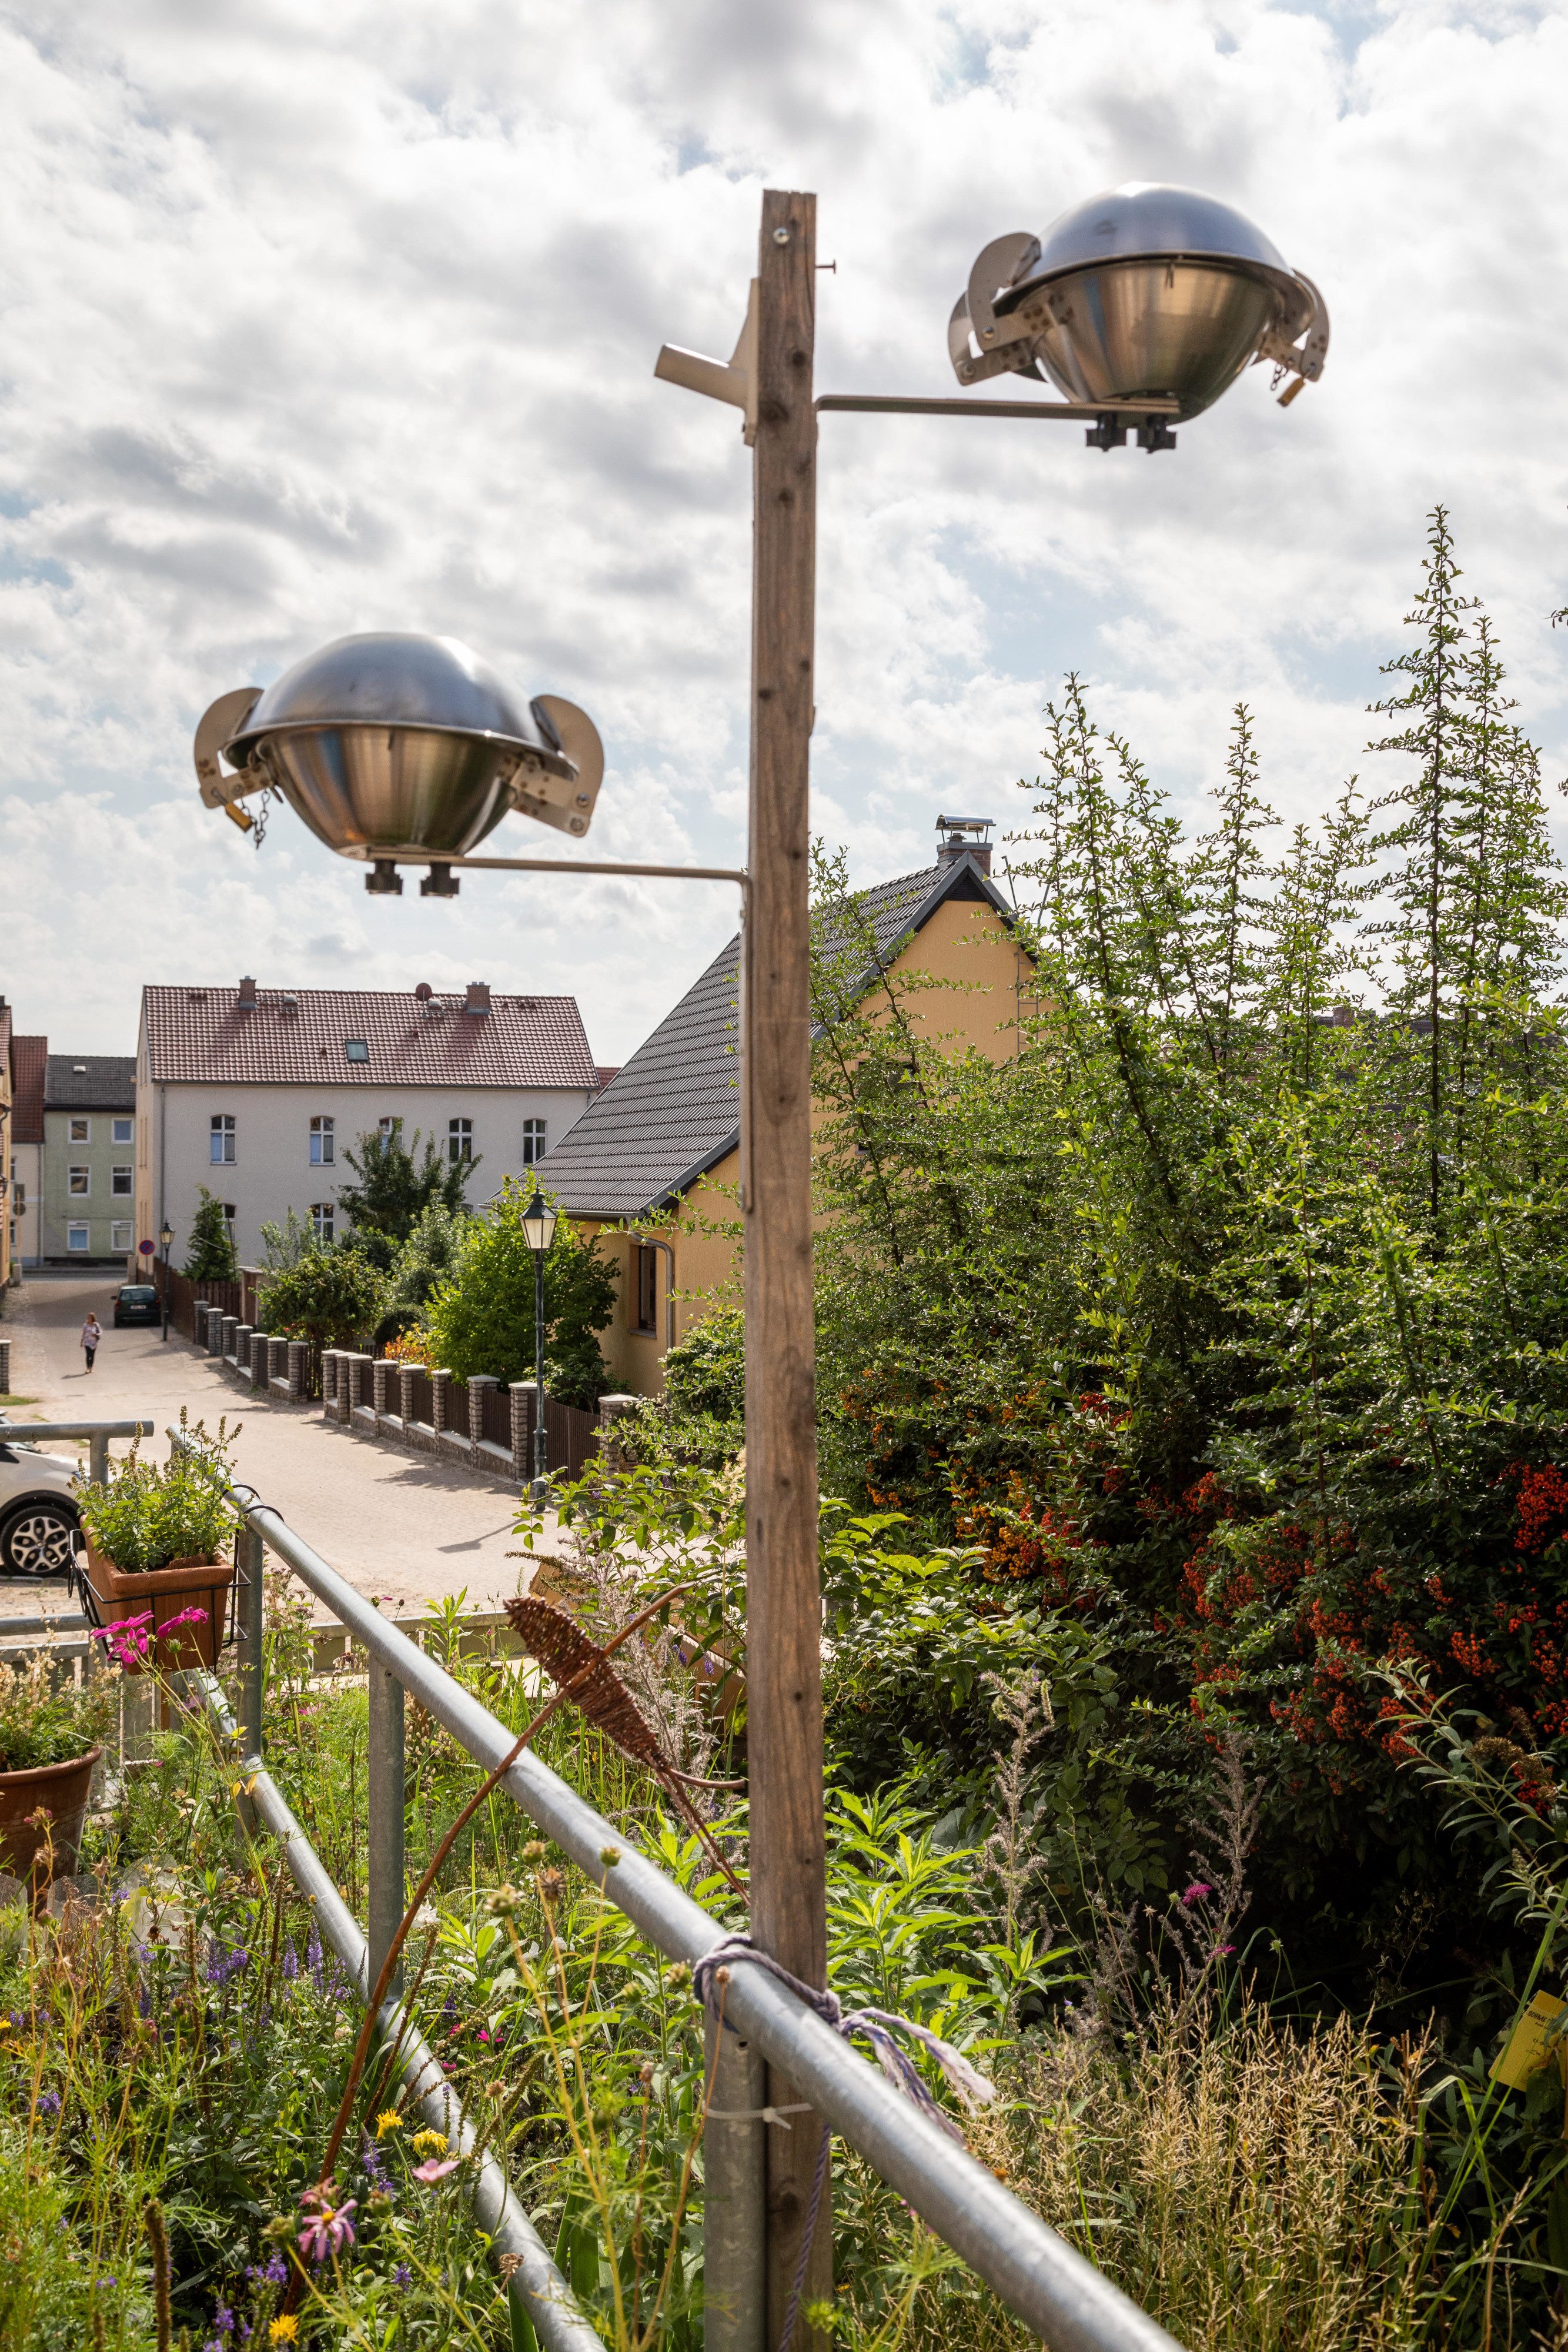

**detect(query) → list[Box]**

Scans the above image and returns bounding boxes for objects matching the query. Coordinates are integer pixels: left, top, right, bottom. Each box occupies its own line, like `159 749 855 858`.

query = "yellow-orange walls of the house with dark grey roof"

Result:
579 901 1034 1397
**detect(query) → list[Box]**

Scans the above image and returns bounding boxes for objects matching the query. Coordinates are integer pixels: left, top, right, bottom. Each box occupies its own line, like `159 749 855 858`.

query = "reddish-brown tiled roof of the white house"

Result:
141 988 597 1094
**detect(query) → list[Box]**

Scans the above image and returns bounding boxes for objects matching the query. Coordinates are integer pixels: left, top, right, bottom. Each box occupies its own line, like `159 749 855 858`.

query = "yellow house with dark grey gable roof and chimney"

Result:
539 818 1034 1397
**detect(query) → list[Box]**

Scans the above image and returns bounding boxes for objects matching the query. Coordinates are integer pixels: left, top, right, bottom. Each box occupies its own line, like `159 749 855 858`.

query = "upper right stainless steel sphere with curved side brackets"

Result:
950 181 1328 416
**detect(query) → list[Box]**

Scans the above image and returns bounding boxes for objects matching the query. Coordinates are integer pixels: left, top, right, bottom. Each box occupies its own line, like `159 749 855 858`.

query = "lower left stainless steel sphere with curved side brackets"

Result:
195 630 604 858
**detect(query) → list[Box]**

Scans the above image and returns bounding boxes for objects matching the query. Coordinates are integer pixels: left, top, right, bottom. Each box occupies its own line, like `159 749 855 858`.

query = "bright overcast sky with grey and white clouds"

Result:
0 0 1568 1061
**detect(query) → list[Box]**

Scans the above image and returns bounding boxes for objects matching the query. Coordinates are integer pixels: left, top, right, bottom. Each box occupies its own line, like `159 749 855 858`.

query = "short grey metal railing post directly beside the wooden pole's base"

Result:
703 2009 769 2352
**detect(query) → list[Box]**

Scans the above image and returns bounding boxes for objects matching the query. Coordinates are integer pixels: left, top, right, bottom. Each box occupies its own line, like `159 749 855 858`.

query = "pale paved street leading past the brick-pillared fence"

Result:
0 1275 552 1616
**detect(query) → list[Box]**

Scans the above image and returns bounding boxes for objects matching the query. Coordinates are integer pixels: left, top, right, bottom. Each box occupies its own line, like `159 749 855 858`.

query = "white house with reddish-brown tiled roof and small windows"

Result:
132 978 600 1265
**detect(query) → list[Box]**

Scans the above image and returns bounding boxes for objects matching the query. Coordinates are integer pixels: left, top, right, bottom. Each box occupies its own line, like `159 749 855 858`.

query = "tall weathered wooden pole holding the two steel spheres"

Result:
741 188 832 2352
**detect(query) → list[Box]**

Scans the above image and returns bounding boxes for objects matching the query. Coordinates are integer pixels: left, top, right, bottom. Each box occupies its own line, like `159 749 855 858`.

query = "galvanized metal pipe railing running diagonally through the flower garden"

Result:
24 1423 1178 2352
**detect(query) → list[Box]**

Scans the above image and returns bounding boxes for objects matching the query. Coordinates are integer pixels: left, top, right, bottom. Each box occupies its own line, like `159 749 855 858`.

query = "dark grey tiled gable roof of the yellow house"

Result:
541 854 1011 1218
